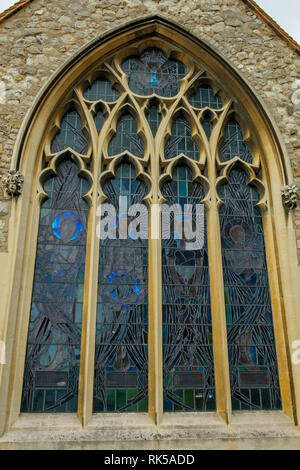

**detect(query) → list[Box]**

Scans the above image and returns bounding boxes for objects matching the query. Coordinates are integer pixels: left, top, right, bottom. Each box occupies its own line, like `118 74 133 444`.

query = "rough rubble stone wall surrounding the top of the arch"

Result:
0 0 300 253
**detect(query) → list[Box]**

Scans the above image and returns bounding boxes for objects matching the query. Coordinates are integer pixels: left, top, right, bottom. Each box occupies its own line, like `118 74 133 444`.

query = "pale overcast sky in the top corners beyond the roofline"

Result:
0 0 300 43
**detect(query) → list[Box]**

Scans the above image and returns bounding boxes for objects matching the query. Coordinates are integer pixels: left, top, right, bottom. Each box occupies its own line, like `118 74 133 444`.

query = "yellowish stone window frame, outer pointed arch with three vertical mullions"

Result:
0 16 300 440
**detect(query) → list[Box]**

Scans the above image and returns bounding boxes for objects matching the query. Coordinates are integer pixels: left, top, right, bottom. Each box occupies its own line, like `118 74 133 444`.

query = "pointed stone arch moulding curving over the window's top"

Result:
12 15 292 183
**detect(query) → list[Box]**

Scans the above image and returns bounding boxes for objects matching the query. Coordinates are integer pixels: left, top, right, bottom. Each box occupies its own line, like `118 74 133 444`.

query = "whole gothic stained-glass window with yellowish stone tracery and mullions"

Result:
5 21 291 434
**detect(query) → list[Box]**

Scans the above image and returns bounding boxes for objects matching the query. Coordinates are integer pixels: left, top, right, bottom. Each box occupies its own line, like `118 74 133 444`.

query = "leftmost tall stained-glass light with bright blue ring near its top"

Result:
21 161 88 412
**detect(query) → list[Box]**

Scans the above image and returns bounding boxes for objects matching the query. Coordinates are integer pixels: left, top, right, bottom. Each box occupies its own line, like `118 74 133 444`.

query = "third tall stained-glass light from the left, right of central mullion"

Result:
162 166 215 411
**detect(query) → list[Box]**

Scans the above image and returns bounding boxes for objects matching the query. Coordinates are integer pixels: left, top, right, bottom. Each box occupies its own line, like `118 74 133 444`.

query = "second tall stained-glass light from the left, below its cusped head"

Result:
94 163 148 413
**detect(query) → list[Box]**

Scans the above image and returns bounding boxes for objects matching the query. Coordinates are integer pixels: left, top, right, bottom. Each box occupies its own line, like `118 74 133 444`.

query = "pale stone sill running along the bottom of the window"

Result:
0 411 300 450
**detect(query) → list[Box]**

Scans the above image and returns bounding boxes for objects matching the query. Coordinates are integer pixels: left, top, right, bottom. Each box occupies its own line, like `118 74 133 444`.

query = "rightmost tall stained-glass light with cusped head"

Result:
220 169 281 410
